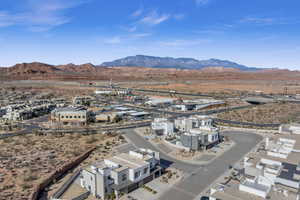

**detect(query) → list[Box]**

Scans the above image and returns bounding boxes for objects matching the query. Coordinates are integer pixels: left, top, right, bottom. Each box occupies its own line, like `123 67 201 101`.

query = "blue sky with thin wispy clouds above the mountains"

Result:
0 0 300 69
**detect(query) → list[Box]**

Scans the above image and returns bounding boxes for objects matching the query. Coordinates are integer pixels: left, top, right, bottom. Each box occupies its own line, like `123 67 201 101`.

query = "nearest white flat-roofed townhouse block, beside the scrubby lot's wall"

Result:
80 149 161 199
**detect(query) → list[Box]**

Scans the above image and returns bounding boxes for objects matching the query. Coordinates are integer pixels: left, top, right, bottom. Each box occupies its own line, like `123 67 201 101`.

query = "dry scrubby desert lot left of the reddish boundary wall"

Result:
0 134 124 200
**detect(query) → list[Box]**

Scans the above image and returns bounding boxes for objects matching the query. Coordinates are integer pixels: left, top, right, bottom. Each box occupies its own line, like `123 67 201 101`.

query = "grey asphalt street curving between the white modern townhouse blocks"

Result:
125 129 262 200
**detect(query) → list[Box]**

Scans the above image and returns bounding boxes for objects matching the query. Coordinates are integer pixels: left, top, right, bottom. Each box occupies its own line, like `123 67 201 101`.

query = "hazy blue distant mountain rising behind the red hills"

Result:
100 55 261 71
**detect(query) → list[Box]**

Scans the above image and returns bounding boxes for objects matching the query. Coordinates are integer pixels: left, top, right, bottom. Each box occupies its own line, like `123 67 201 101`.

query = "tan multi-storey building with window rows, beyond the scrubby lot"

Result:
51 107 89 126
